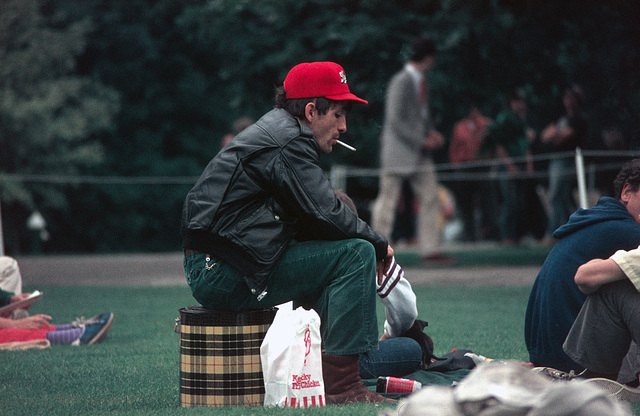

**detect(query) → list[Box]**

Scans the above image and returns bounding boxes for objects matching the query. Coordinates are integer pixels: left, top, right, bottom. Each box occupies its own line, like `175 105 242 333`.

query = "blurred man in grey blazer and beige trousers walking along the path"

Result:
372 38 451 262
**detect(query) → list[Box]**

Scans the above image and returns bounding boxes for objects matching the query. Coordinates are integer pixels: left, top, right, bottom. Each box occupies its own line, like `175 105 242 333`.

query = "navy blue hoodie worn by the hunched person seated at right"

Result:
524 197 640 371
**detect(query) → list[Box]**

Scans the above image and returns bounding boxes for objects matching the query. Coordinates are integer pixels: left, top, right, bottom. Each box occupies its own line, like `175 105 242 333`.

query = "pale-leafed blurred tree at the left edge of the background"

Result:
0 0 118 251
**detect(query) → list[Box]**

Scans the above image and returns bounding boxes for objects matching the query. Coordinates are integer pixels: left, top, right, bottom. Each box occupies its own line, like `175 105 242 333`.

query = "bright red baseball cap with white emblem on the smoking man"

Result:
284 62 368 104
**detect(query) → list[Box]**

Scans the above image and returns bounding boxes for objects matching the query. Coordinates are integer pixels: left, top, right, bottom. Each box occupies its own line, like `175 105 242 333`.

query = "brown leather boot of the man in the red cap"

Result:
322 354 395 404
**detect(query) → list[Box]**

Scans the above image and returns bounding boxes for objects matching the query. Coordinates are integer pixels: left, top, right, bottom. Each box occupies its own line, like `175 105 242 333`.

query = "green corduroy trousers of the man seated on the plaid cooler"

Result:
184 239 378 355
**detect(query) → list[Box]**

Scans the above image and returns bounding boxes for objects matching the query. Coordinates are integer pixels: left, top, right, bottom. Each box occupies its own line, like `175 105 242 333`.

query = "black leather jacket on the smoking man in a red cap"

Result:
182 109 387 299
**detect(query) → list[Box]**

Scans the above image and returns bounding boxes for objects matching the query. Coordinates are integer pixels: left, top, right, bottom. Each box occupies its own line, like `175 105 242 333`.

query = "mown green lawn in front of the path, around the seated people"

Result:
0 286 640 416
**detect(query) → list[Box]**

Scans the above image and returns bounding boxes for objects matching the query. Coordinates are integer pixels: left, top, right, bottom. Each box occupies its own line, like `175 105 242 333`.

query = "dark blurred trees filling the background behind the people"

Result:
0 0 640 254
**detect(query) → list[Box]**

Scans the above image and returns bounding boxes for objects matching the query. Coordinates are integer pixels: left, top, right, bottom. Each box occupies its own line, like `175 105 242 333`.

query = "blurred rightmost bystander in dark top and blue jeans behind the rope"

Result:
540 85 587 244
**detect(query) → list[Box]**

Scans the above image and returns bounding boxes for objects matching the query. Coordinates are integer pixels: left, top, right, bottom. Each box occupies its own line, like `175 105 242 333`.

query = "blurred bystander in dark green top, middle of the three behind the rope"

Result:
489 92 535 245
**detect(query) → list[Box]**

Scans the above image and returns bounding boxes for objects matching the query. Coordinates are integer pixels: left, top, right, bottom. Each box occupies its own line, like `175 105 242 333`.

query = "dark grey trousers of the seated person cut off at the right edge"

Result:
563 280 640 383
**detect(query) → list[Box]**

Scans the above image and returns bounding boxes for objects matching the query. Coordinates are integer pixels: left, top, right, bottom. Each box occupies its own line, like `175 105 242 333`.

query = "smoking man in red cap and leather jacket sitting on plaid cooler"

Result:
182 62 393 404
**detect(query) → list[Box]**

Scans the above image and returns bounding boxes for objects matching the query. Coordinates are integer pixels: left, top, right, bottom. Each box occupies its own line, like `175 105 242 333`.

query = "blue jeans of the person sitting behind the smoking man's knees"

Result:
360 337 422 379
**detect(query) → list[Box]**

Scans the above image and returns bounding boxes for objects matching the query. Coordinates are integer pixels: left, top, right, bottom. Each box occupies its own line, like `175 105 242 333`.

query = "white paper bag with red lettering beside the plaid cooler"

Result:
260 307 325 407
